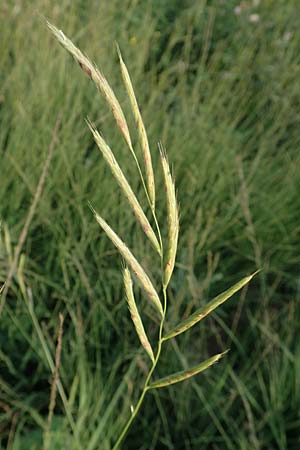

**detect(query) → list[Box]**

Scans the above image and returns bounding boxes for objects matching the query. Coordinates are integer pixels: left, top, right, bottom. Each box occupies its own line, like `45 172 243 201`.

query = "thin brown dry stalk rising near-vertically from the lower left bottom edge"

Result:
43 314 64 450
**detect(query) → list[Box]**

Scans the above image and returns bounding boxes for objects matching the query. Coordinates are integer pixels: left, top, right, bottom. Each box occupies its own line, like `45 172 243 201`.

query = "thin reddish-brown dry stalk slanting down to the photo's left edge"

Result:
0 114 61 316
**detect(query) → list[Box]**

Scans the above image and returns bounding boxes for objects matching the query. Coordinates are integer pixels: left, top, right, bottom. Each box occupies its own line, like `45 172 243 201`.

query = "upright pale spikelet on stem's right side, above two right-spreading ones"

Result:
159 145 179 287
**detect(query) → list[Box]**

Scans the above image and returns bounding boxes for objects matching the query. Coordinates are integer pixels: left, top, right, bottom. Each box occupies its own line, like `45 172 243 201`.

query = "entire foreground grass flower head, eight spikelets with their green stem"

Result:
48 23 254 450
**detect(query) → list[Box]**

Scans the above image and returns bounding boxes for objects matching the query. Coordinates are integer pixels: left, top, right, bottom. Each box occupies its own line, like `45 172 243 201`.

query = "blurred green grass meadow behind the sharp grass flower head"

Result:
0 0 300 450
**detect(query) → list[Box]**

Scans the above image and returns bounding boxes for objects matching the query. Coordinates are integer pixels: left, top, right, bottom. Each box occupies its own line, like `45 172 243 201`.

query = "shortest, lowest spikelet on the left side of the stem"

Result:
123 267 154 362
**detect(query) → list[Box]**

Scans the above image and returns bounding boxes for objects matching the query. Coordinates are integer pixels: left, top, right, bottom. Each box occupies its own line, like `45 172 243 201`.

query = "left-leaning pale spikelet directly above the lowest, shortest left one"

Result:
91 207 163 317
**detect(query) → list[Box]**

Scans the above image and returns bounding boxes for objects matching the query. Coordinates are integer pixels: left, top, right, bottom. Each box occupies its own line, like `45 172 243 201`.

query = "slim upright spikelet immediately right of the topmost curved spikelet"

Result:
117 45 155 210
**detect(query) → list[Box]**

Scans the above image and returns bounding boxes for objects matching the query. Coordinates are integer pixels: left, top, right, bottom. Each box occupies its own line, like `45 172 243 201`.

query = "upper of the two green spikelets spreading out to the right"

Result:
163 272 257 340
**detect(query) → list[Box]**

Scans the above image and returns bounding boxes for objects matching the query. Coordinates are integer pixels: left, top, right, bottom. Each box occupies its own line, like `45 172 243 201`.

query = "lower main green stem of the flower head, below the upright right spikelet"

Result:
112 286 167 450
